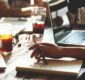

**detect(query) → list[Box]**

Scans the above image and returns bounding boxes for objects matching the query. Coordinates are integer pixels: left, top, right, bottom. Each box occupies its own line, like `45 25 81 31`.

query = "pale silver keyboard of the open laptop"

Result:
58 30 85 44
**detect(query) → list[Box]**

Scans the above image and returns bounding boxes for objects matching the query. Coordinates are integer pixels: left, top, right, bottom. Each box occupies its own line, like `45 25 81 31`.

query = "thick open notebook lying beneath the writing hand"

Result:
16 59 82 78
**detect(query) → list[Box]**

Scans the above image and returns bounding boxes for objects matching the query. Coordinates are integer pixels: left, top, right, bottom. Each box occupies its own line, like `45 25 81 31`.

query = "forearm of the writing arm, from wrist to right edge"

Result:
62 47 85 58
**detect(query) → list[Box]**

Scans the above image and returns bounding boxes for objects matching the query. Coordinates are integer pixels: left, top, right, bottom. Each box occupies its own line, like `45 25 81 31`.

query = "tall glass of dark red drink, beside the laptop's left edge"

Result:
32 6 46 42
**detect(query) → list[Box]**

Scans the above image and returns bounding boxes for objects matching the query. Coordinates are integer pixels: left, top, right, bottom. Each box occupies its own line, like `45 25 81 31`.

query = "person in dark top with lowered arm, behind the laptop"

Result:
68 0 85 26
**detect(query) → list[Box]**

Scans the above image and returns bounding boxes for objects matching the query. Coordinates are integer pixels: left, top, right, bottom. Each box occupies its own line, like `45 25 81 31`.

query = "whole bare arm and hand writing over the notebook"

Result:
29 43 85 59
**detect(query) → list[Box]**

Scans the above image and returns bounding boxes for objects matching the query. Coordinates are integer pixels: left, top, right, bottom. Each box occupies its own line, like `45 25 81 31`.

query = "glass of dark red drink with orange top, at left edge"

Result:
0 24 13 52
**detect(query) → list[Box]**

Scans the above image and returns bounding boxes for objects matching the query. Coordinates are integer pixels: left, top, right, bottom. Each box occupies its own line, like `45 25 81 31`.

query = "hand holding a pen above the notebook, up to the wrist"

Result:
29 43 62 60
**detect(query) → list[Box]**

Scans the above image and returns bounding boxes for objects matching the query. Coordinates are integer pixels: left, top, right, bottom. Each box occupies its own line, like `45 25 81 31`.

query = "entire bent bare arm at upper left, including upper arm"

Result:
0 0 31 17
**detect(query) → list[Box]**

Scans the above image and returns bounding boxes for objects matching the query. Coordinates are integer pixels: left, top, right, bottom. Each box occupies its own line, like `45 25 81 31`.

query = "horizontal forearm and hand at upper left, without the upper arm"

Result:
0 8 31 17
